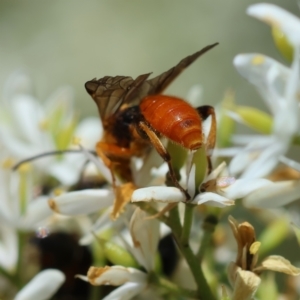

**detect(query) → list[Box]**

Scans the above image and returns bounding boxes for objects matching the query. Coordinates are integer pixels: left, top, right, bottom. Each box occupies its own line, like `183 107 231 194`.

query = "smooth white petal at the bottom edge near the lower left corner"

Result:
15 269 65 300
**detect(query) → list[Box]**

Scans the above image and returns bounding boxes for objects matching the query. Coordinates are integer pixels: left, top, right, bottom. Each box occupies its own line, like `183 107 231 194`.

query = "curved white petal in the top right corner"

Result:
247 3 300 45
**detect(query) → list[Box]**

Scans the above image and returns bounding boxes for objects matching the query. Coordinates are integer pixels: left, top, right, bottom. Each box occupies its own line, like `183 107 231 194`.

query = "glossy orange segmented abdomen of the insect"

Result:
140 95 203 150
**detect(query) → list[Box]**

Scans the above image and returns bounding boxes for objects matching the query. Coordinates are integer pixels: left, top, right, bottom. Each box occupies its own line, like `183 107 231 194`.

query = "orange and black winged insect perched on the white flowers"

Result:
85 43 218 200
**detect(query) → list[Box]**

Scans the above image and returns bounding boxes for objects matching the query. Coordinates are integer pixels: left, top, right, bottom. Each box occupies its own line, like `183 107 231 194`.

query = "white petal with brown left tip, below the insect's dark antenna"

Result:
48 189 114 216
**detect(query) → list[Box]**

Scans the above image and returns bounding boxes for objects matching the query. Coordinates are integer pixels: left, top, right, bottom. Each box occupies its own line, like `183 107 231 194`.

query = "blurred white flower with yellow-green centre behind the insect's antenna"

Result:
0 72 102 185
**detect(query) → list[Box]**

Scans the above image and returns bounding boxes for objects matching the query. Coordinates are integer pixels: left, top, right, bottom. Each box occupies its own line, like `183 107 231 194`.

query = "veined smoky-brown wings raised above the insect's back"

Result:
85 43 218 119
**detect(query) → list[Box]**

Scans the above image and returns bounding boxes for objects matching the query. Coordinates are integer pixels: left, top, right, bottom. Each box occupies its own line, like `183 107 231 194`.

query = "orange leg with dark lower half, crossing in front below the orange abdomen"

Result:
138 121 191 200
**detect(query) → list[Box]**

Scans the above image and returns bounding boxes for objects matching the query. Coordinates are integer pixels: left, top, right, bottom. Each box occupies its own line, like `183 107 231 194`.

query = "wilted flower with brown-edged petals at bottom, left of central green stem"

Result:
78 208 159 300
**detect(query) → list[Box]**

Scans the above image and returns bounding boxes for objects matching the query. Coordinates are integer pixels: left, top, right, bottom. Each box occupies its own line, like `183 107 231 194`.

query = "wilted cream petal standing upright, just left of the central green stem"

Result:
130 208 159 272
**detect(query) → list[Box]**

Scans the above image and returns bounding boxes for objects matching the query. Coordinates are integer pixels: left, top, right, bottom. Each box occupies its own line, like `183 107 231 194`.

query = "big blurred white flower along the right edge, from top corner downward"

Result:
229 4 300 178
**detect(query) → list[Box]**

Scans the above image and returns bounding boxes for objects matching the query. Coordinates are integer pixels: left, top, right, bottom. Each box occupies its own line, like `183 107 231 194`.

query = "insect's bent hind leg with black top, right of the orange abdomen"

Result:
196 105 217 174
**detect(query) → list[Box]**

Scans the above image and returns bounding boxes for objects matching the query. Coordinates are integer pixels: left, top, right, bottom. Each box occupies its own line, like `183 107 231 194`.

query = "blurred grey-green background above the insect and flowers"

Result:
0 0 299 116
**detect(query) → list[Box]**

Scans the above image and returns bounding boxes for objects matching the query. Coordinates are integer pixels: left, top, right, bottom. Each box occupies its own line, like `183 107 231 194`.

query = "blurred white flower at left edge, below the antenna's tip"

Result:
0 160 52 274
